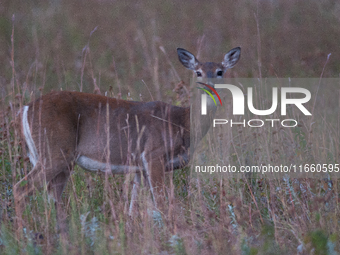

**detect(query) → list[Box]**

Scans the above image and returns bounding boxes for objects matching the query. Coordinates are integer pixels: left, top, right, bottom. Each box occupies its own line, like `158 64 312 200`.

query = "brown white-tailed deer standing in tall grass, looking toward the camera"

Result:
14 48 241 222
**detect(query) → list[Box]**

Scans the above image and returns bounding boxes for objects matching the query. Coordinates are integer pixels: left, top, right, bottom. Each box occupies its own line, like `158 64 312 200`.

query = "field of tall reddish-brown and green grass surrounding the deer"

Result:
0 0 340 255
